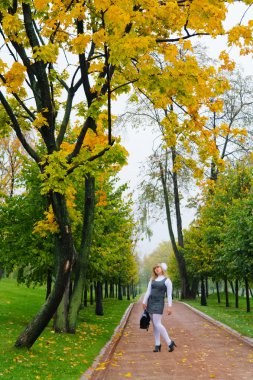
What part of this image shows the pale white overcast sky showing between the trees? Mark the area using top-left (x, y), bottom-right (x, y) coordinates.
top-left (113, 4), bottom-right (253, 255)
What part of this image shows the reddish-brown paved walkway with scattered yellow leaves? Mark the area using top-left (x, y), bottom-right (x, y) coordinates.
top-left (80, 302), bottom-right (253, 380)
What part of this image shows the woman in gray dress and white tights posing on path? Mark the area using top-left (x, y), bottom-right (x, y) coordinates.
top-left (143, 263), bottom-right (176, 352)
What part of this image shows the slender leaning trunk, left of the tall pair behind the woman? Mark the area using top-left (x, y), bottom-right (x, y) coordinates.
top-left (159, 159), bottom-right (191, 299)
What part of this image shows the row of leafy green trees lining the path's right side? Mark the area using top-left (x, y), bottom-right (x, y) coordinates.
top-left (185, 157), bottom-right (253, 311)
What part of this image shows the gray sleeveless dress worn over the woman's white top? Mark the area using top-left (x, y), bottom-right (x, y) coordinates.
top-left (147, 278), bottom-right (167, 314)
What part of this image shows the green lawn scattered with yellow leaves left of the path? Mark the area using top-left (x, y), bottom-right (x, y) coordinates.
top-left (0, 279), bottom-right (134, 380)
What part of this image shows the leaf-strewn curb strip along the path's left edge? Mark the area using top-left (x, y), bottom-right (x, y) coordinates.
top-left (79, 302), bottom-right (134, 380)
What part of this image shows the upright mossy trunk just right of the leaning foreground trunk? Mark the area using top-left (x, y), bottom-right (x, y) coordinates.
top-left (68, 175), bottom-right (95, 333)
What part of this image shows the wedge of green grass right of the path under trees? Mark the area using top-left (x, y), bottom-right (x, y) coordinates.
top-left (185, 293), bottom-right (253, 338)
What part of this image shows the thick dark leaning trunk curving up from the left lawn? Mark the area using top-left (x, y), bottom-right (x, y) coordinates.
top-left (15, 193), bottom-right (74, 348)
